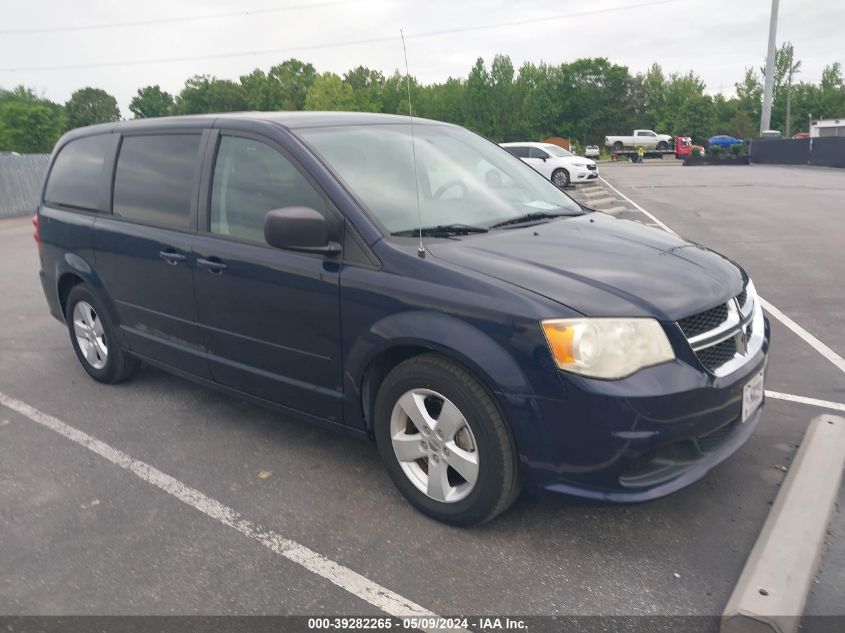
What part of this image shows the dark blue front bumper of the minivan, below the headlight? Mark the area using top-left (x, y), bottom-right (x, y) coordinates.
top-left (504, 321), bottom-right (769, 502)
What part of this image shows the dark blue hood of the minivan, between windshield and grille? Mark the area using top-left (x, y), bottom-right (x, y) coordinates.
top-left (427, 213), bottom-right (746, 321)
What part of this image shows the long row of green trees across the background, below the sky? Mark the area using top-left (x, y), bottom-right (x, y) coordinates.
top-left (0, 42), bottom-right (845, 153)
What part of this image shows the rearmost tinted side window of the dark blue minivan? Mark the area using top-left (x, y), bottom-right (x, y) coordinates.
top-left (44, 134), bottom-right (118, 211)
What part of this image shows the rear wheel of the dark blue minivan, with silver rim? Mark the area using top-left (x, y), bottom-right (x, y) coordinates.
top-left (65, 284), bottom-right (139, 384)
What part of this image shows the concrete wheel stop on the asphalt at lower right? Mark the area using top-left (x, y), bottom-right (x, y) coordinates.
top-left (721, 415), bottom-right (845, 633)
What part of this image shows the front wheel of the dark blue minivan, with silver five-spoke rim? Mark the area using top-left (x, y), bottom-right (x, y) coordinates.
top-left (374, 354), bottom-right (521, 526)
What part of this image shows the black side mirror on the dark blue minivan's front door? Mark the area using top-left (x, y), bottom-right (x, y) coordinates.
top-left (264, 207), bottom-right (341, 256)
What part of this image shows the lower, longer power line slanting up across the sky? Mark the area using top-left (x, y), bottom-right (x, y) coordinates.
top-left (0, 0), bottom-right (688, 72)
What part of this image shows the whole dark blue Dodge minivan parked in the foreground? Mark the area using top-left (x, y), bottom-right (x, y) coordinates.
top-left (35, 112), bottom-right (769, 525)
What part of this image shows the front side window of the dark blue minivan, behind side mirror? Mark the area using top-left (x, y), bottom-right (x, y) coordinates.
top-left (210, 136), bottom-right (328, 243)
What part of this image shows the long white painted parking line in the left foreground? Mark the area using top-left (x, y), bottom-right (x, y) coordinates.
top-left (0, 392), bottom-right (460, 631)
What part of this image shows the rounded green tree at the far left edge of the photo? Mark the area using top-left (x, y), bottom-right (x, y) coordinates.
top-left (0, 99), bottom-right (63, 154)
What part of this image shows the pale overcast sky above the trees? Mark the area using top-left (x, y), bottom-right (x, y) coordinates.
top-left (0, 0), bottom-right (845, 116)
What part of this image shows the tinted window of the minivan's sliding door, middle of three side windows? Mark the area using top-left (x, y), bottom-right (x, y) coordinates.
top-left (114, 134), bottom-right (200, 229)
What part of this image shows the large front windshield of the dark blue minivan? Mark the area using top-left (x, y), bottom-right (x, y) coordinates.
top-left (297, 123), bottom-right (583, 234)
